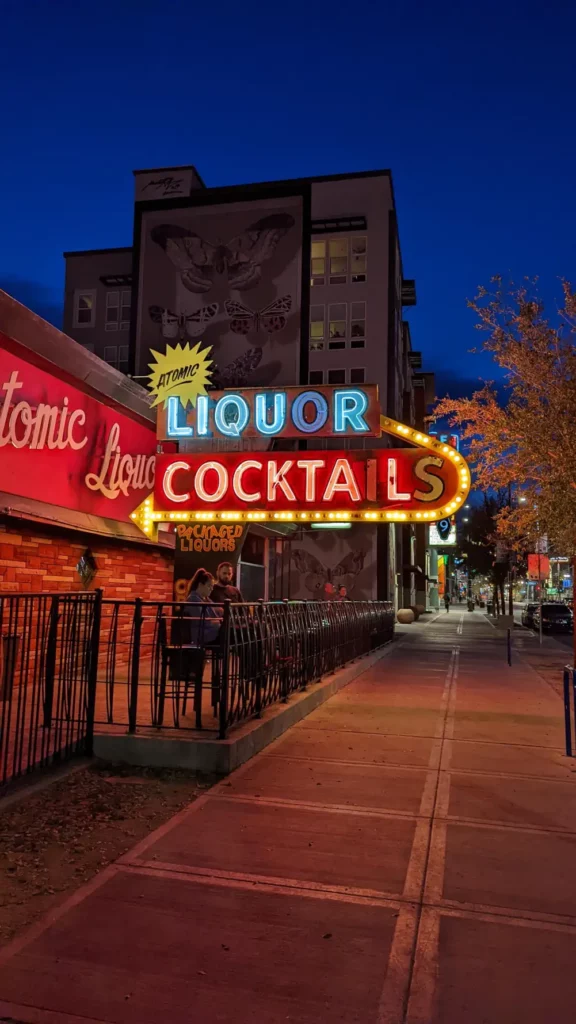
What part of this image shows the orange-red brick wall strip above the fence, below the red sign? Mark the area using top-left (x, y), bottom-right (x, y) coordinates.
top-left (0, 519), bottom-right (173, 601)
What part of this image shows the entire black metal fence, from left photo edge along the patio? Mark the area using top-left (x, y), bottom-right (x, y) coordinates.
top-left (0, 591), bottom-right (394, 787)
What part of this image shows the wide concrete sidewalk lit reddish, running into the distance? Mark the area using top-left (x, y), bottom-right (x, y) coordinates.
top-left (0, 608), bottom-right (576, 1024)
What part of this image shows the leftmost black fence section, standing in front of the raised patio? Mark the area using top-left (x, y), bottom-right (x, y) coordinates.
top-left (0, 592), bottom-right (101, 786)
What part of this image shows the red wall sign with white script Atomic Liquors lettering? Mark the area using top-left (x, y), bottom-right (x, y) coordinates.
top-left (0, 334), bottom-right (156, 520)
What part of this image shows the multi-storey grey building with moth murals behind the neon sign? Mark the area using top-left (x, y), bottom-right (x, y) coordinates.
top-left (65, 167), bottom-right (433, 604)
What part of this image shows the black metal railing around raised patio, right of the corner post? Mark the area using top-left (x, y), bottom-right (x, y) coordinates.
top-left (95, 599), bottom-right (394, 738)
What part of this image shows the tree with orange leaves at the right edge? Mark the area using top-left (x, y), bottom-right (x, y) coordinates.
top-left (436, 276), bottom-right (576, 555)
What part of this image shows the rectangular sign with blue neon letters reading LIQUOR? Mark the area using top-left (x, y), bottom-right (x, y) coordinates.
top-left (157, 384), bottom-right (382, 440)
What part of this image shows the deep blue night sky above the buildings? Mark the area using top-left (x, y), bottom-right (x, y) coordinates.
top-left (0, 0), bottom-right (576, 394)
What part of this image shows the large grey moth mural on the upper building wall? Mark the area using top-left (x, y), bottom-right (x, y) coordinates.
top-left (137, 197), bottom-right (301, 387)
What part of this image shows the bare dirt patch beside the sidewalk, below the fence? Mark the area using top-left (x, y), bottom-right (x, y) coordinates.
top-left (0, 763), bottom-right (215, 946)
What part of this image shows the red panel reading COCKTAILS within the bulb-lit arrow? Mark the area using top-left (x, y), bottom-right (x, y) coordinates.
top-left (154, 449), bottom-right (460, 519)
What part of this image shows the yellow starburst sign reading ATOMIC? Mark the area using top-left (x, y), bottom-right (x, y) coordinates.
top-left (149, 342), bottom-right (212, 409)
